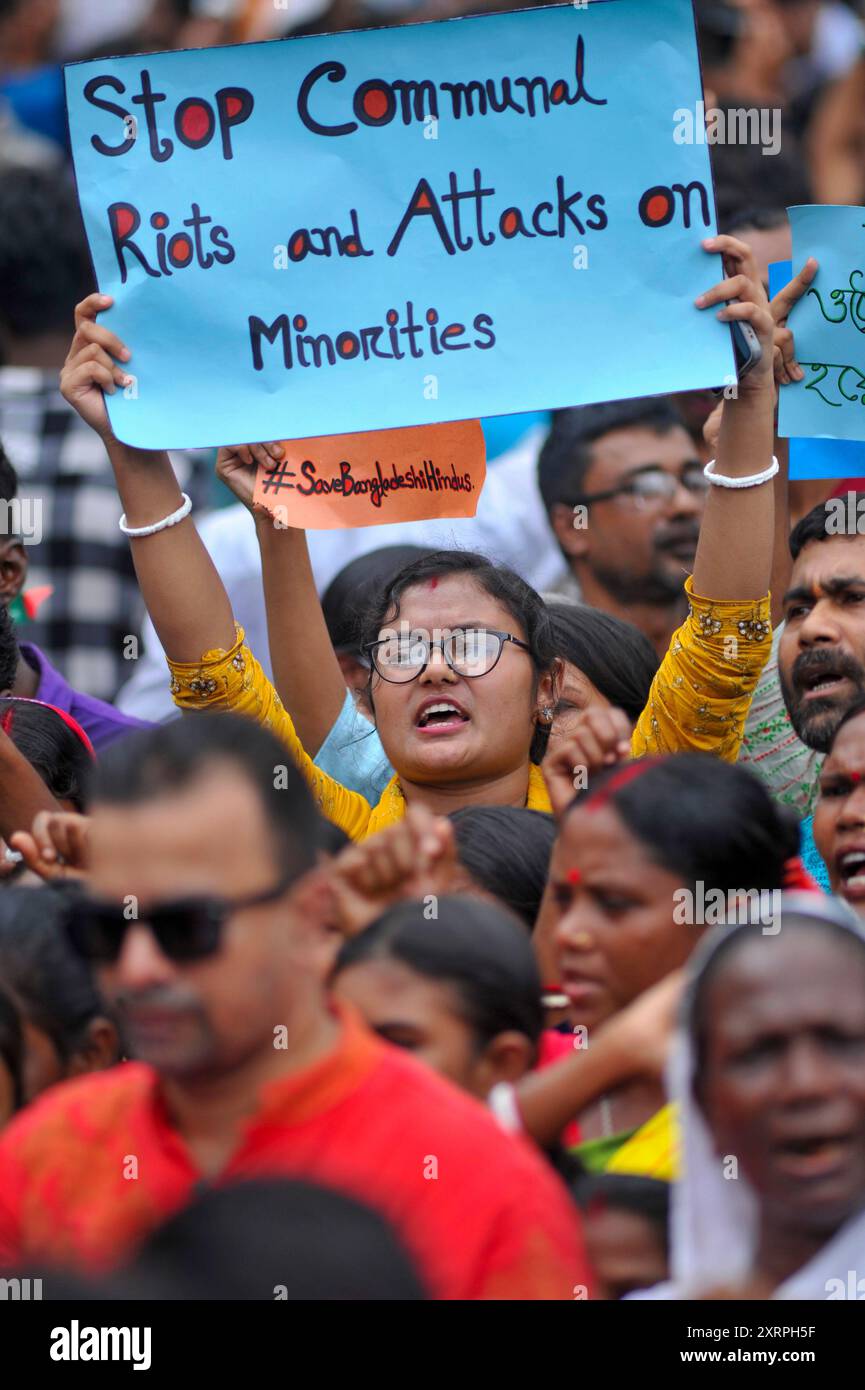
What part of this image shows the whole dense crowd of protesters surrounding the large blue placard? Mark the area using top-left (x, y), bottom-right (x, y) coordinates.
top-left (0, 0), bottom-right (865, 1301)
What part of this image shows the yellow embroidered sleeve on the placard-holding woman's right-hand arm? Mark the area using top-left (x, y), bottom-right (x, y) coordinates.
top-left (631, 577), bottom-right (772, 763)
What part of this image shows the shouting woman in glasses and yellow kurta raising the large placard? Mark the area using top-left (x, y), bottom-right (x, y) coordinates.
top-left (61, 236), bottom-right (777, 838)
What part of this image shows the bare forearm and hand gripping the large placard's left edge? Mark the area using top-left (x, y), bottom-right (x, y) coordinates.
top-left (60, 295), bottom-right (235, 662)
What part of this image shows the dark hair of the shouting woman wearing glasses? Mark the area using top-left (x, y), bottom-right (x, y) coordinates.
top-left (364, 550), bottom-right (558, 763)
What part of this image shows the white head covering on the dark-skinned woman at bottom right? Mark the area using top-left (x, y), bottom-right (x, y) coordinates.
top-left (633, 892), bottom-right (865, 1300)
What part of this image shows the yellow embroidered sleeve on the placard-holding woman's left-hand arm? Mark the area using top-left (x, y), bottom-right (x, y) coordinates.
top-left (168, 627), bottom-right (371, 840)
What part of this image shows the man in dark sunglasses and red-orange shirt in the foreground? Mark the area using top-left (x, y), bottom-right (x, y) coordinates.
top-left (0, 714), bottom-right (588, 1298)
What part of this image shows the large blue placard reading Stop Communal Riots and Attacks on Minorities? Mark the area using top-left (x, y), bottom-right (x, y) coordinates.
top-left (65, 0), bottom-right (734, 448)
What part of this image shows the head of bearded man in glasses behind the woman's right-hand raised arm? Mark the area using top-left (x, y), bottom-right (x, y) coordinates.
top-left (538, 399), bottom-right (708, 656)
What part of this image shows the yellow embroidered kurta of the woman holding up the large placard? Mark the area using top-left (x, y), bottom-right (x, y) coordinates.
top-left (168, 580), bottom-right (772, 840)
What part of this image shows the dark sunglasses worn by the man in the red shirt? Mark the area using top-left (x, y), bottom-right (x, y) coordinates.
top-left (64, 874), bottom-right (292, 965)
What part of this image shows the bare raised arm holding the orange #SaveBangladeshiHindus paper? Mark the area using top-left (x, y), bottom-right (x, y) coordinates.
top-left (217, 443), bottom-right (345, 756)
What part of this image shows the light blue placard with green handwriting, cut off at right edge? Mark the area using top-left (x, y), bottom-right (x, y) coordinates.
top-left (779, 206), bottom-right (865, 439)
